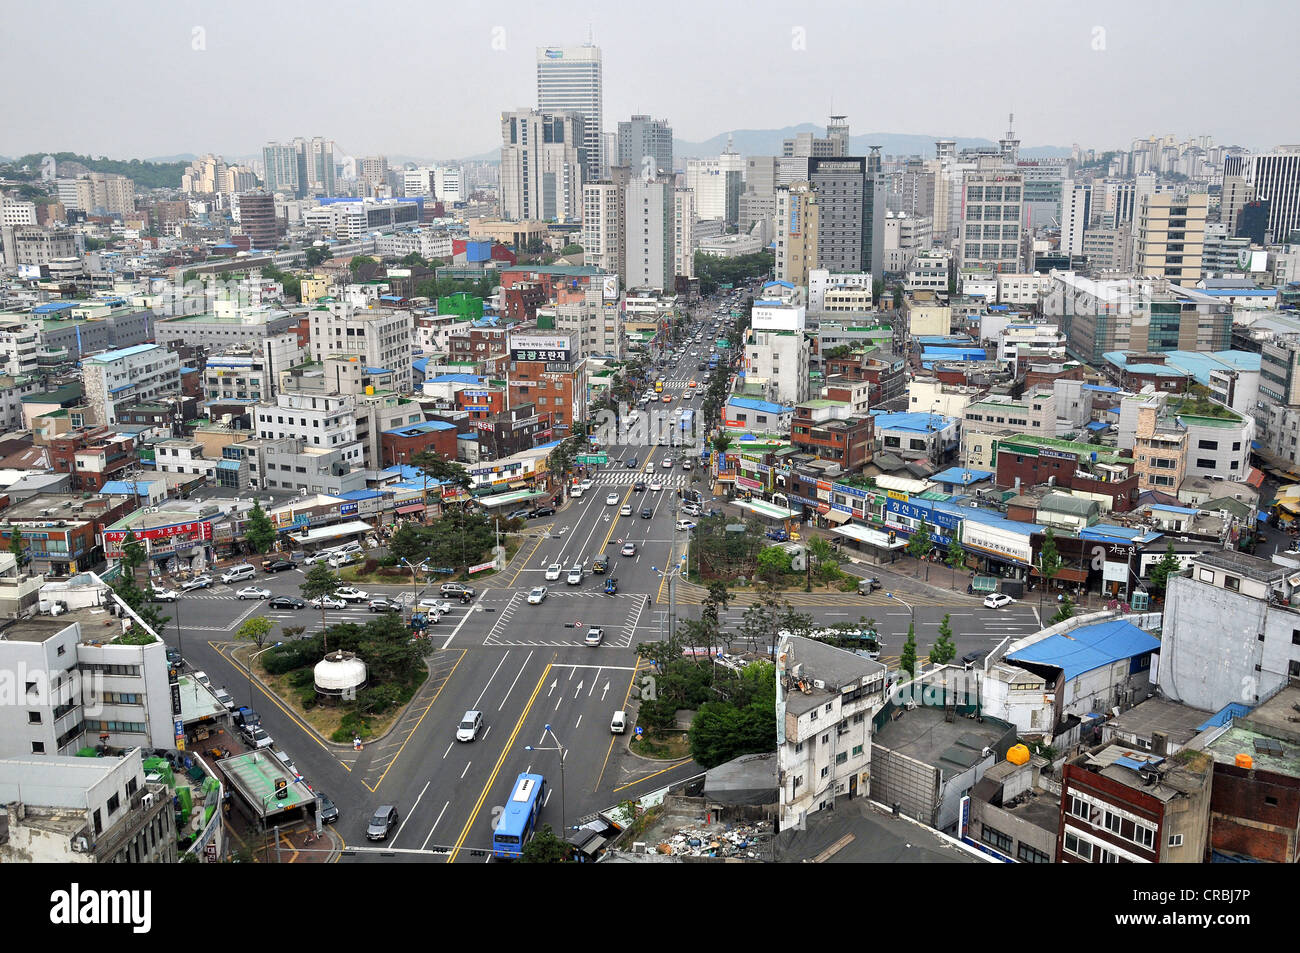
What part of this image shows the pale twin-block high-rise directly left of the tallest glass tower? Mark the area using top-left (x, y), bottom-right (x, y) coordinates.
top-left (501, 109), bottom-right (589, 221)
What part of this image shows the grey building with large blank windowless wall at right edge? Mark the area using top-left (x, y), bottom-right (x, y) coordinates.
top-left (1158, 551), bottom-right (1300, 711)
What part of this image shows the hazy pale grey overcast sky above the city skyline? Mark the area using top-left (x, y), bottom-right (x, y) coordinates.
top-left (0, 0), bottom-right (1300, 159)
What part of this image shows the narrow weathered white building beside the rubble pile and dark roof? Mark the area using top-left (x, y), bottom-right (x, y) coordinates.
top-left (776, 636), bottom-right (888, 827)
